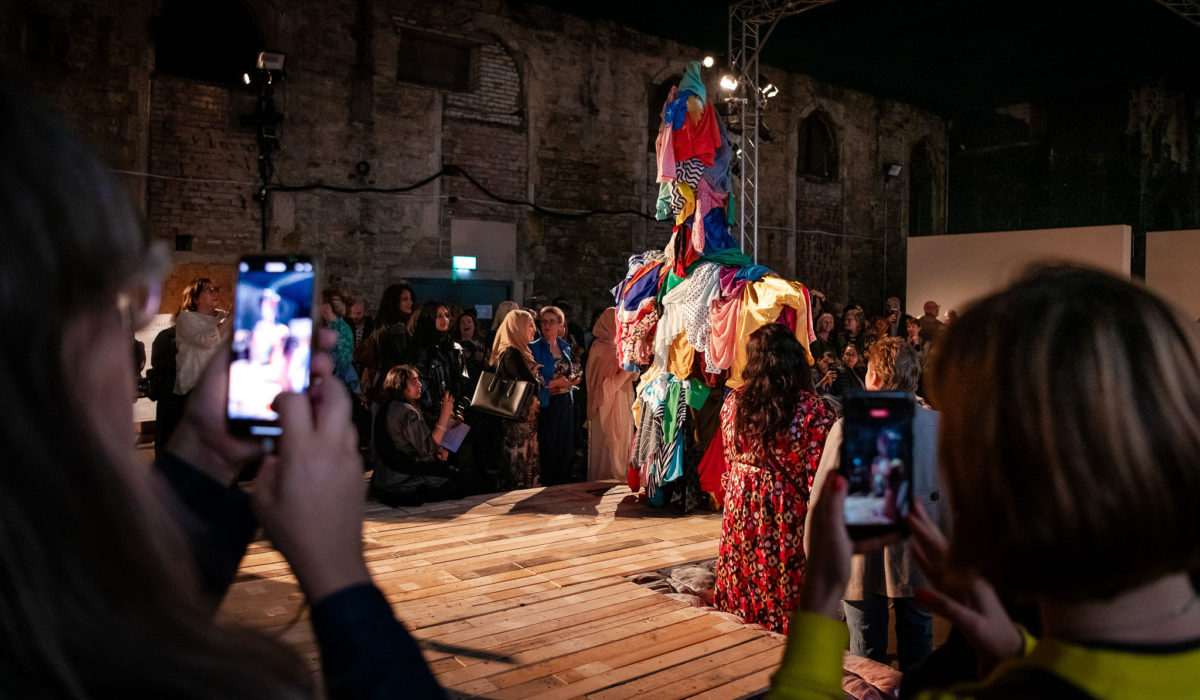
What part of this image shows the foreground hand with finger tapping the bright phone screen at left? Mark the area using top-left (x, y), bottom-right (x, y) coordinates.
top-left (253, 358), bottom-right (371, 603)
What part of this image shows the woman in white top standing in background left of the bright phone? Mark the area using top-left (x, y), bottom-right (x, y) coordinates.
top-left (175, 277), bottom-right (233, 394)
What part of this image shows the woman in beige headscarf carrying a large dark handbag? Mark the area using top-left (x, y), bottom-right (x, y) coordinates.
top-left (491, 309), bottom-right (541, 490)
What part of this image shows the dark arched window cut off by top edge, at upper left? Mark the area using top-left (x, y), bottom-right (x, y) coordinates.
top-left (155, 0), bottom-right (262, 85)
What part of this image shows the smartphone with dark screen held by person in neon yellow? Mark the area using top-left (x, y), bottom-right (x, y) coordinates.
top-left (838, 391), bottom-right (916, 539)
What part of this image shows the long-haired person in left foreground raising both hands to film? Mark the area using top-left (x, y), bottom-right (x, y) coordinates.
top-left (0, 84), bottom-right (439, 698)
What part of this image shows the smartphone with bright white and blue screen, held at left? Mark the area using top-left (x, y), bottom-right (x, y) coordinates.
top-left (226, 255), bottom-right (317, 437)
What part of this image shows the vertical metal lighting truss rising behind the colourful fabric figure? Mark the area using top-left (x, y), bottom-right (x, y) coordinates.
top-left (725, 0), bottom-right (840, 263)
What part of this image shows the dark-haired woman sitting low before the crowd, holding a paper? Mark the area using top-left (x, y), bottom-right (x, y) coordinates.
top-left (371, 365), bottom-right (454, 507)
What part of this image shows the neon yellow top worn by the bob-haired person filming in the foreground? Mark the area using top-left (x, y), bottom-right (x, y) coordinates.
top-left (768, 611), bottom-right (1200, 700)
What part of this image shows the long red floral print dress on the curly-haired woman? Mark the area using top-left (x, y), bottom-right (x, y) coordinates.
top-left (714, 389), bottom-right (836, 634)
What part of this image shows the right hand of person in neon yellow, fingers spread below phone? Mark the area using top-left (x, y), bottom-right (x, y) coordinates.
top-left (906, 502), bottom-right (1025, 671)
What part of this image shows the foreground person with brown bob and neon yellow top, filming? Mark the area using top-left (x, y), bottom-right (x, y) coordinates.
top-left (770, 265), bottom-right (1200, 700)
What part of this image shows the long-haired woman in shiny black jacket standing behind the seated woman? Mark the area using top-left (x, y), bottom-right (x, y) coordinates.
top-left (404, 301), bottom-right (473, 429)
